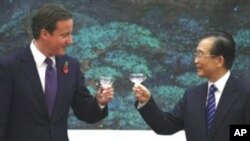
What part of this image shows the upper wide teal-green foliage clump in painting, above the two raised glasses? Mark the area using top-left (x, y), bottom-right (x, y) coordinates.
top-left (69, 22), bottom-right (160, 59)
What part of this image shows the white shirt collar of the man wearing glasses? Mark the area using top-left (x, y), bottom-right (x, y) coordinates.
top-left (208, 71), bottom-right (231, 93)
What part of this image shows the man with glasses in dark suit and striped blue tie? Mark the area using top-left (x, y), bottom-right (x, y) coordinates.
top-left (133, 31), bottom-right (250, 141)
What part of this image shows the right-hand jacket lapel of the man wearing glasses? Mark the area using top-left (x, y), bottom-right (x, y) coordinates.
top-left (210, 75), bottom-right (238, 137)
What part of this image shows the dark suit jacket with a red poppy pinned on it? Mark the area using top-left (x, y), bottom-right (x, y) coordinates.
top-left (0, 47), bottom-right (107, 141)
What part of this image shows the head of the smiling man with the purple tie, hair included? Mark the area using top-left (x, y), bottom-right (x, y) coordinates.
top-left (32, 4), bottom-right (73, 57)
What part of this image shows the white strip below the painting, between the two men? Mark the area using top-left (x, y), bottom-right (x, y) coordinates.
top-left (68, 130), bottom-right (186, 141)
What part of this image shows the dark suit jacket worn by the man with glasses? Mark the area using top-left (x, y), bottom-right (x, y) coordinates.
top-left (139, 75), bottom-right (250, 141)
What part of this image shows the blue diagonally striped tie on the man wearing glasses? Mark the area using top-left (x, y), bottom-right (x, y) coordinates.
top-left (206, 84), bottom-right (217, 134)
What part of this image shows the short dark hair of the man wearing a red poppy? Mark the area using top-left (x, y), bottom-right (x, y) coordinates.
top-left (32, 4), bottom-right (72, 39)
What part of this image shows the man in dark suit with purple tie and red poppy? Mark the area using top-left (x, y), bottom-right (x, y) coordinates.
top-left (0, 5), bottom-right (113, 141)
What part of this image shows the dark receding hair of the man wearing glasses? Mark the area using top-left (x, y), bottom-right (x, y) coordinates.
top-left (202, 31), bottom-right (235, 69)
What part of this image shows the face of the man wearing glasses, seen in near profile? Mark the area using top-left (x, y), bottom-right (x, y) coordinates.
top-left (194, 38), bottom-right (218, 80)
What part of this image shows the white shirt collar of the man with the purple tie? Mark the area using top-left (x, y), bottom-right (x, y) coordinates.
top-left (30, 40), bottom-right (56, 67)
